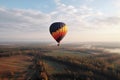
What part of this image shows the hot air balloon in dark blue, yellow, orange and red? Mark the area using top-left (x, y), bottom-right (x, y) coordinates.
top-left (49, 22), bottom-right (67, 46)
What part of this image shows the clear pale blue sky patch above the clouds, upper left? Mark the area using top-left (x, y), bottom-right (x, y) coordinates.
top-left (0, 0), bottom-right (56, 12)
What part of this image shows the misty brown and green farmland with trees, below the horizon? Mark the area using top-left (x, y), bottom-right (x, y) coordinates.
top-left (0, 42), bottom-right (120, 80)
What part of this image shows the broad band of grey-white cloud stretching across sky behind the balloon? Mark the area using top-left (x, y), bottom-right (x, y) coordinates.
top-left (0, 0), bottom-right (119, 32)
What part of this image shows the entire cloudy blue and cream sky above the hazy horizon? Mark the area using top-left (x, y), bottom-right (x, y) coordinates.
top-left (0, 0), bottom-right (120, 43)
